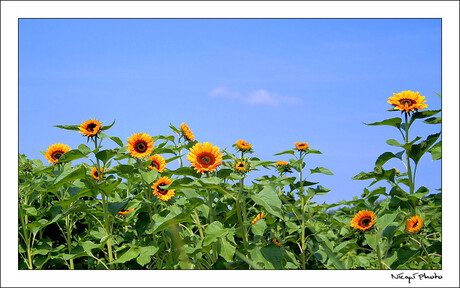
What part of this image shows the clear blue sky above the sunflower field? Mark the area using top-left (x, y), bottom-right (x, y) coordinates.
top-left (19, 19), bottom-right (442, 203)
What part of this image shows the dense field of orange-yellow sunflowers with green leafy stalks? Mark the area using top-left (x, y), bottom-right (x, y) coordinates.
top-left (18, 91), bottom-right (442, 270)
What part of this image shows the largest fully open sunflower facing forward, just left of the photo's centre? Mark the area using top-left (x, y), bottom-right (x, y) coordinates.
top-left (187, 142), bottom-right (223, 173)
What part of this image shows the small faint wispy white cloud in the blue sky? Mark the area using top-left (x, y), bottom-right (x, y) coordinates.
top-left (209, 87), bottom-right (302, 106)
